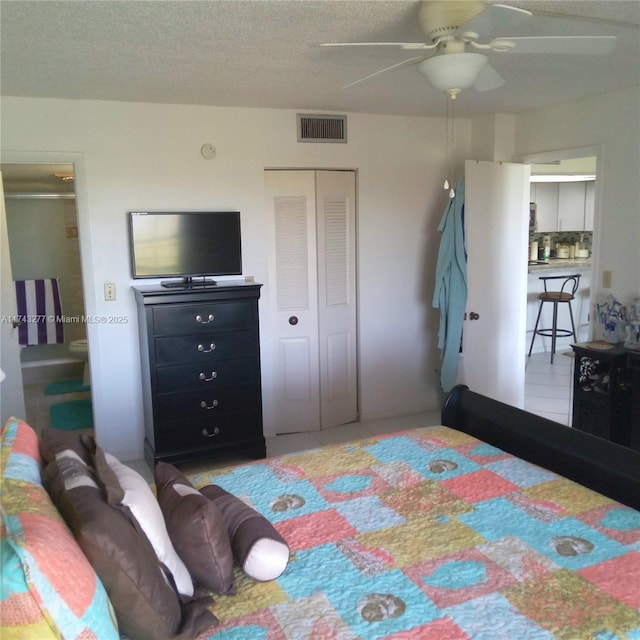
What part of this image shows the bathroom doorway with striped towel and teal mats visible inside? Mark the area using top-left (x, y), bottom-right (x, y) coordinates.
top-left (1, 162), bottom-right (93, 438)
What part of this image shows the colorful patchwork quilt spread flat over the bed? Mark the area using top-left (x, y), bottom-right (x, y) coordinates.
top-left (189, 427), bottom-right (640, 640)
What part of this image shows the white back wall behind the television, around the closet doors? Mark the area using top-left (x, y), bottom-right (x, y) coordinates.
top-left (2, 98), bottom-right (460, 460)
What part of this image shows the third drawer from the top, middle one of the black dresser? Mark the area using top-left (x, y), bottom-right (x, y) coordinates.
top-left (156, 356), bottom-right (260, 394)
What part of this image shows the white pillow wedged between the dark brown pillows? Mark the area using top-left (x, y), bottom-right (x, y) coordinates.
top-left (105, 452), bottom-right (193, 597)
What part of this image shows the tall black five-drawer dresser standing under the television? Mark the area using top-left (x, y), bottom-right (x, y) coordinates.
top-left (134, 281), bottom-right (266, 464)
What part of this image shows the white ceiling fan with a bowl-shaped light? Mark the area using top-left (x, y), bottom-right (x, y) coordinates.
top-left (320, 0), bottom-right (616, 99)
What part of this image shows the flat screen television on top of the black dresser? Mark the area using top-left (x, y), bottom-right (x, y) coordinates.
top-left (129, 211), bottom-right (242, 287)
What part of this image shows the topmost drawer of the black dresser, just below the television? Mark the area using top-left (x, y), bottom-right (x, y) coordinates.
top-left (153, 301), bottom-right (254, 336)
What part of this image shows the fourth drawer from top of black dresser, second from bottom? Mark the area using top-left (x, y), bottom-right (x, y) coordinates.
top-left (155, 384), bottom-right (260, 422)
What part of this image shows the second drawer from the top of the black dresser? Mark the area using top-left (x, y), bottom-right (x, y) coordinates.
top-left (154, 330), bottom-right (257, 365)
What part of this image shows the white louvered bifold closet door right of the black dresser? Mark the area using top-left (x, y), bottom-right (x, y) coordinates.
top-left (265, 171), bottom-right (357, 433)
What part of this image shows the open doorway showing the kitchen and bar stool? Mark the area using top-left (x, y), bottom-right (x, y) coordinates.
top-left (524, 147), bottom-right (601, 425)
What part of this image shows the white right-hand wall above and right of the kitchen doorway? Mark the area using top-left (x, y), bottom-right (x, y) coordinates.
top-left (515, 87), bottom-right (640, 302)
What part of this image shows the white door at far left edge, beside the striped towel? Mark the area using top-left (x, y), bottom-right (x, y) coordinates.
top-left (0, 173), bottom-right (26, 424)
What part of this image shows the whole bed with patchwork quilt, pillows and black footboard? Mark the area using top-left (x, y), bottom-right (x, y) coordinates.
top-left (0, 386), bottom-right (640, 640)
